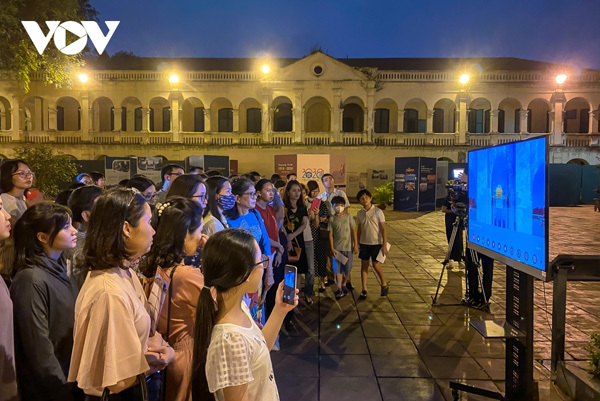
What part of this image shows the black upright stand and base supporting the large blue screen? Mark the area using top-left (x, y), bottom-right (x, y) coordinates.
top-left (450, 266), bottom-right (539, 401)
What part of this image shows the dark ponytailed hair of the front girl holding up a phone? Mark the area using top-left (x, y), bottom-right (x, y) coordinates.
top-left (192, 229), bottom-right (256, 401)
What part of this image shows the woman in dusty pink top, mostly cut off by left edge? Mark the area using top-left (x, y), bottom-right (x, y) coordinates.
top-left (0, 198), bottom-right (18, 401)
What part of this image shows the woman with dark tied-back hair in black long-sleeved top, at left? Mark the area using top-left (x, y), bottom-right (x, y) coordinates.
top-left (10, 202), bottom-right (77, 401)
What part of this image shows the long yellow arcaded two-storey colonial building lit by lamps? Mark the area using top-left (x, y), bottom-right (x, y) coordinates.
top-left (0, 52), bottom-right (600, 173)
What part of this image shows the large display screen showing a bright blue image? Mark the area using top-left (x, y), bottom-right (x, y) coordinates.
top-left (468, 136), bottom-right (548, 280)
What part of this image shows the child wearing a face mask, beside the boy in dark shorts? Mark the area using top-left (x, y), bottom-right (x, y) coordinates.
top-left (328, 196), bottom-right (358, 299)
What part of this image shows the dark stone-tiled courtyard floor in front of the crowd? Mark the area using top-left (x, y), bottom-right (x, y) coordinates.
top-left (271, 205), bottom-right (600, 401)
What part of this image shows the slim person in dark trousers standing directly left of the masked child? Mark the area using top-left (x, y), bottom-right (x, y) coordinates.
top-left (306, 180), bottom-right (329, 292)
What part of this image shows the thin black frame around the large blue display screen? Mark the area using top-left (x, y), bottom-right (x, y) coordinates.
top-left (466, 135), bottom-right (552, 281)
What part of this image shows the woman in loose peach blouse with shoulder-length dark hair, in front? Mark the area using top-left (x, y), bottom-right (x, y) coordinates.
top-left (69, 187), bottom-right (174, 401)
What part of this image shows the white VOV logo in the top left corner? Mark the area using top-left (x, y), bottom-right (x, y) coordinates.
top-left (21, 21), bottom-right (120, 56)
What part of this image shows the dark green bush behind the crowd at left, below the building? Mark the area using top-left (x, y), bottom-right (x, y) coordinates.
top-left (15, 145), bottom-right (77, 198)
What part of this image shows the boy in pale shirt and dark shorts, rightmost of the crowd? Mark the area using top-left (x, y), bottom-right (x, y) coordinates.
top-left (356, 189), bottom-right (389, 299)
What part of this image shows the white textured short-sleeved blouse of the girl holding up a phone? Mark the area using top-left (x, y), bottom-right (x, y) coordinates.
top-left (206, 302), bottom-right (279, 401)
